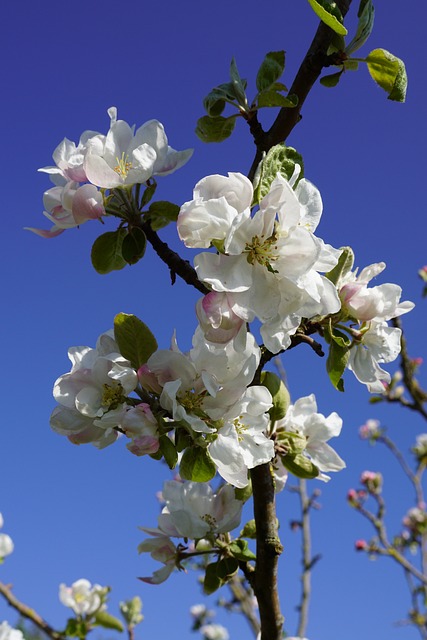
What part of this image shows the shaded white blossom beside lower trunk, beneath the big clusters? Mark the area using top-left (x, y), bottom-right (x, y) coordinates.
top-left (158, 480), bottom-right (243, 540)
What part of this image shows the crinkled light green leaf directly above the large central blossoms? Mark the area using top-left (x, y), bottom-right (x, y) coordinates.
top-left (254, 144), bottom-right (304, 204)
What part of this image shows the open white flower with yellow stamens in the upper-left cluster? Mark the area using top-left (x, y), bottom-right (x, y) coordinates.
top-left (83, 107), bottom-right (193, 189)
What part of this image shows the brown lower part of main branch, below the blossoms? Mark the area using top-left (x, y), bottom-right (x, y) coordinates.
top-left (251, 463), bottom-right (284, 640)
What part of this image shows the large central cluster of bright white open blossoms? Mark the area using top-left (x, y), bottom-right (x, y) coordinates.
top-left (177, 165), bottom-right (341, 353)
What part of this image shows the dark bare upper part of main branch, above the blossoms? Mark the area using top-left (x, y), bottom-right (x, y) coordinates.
top-left (248, 0), bottom-right (351, 180)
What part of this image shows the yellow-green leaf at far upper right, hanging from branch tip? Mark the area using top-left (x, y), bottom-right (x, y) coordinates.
top-left (365, 49), bottom-right (408, 102)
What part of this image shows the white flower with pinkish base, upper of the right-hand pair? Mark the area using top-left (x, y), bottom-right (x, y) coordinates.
top-left (338, 262), bottom-right (415, 323)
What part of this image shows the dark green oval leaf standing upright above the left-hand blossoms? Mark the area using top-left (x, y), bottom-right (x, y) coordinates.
top-left (114, 313), bottom-right (157, 370)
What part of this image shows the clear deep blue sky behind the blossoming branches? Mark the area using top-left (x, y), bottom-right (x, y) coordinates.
top-left (0, 0), bottom-right (427, 640)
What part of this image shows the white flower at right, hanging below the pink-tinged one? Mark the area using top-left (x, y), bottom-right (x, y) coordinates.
top-left (347, 322), bottom-right (402, 393)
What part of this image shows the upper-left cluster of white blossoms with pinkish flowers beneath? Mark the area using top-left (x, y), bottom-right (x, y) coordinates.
top-left (28, 107), bottom-right (193, 238)
